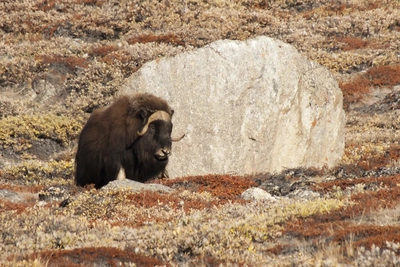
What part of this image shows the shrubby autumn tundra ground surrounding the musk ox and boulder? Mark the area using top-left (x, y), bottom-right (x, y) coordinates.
top-left (0, 0), bottom-right (400, 266)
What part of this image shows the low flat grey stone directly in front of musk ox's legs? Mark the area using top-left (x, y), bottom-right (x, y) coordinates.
top-left (101, 179), bottom-right (173, 193)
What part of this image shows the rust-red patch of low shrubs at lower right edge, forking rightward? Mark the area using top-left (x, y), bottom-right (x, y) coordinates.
top-left (285, 184), bottom-right (400, 253)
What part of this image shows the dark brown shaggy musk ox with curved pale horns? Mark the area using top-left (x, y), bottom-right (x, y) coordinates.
top-left (75, 93), bottom-right (183, 188)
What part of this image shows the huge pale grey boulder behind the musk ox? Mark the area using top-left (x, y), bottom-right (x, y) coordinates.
top-left (120, 37), bottom-right (345, 177)
